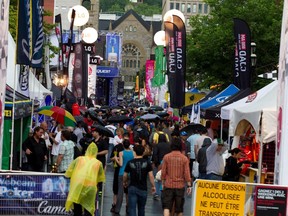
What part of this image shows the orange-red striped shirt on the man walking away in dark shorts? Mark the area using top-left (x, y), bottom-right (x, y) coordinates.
top-left (161, 151), bottom-right (191, 189)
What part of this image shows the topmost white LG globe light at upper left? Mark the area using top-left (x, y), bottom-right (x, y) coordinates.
top-left (68, 5), bottom-right (89, 26)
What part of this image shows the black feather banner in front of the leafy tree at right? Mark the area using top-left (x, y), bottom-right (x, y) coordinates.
top-left (234, 18), bottom-right (251, 89)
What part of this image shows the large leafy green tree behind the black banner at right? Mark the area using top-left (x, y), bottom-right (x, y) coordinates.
top-left (187, 0), bottom-right (283, 88)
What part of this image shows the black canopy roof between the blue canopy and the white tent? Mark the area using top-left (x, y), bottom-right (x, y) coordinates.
top-left (201, 88), bottom-right (252, 119)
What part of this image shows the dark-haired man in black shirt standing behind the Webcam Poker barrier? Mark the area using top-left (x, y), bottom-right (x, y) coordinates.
top-left (22, 126), bottom-right (48, 172)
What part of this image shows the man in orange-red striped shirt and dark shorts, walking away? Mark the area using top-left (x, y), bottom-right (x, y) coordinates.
top-left (161, 138), bottom-right (192, 216)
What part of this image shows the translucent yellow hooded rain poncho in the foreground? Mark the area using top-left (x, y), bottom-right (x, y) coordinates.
top-left (65, 142), bottom-right (105, 215)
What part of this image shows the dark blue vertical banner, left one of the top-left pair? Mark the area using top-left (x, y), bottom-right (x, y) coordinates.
top-left (16, 0), bottom-right (30, 65)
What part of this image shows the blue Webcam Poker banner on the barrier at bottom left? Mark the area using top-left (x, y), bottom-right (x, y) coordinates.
top-left (0, 173), bottom-right (72, 215)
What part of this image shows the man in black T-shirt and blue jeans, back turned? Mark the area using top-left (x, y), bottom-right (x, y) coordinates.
top-left (123, 145), bottom-right (156, 216)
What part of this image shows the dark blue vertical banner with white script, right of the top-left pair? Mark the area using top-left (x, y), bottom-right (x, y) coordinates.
top-left (31, 0), bottom-right (44, 68)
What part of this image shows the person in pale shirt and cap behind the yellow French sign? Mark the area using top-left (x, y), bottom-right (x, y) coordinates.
top-left (206, 139), bottom-right (228, 181)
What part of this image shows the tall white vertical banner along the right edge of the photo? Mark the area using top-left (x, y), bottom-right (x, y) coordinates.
top-left (274, 0), bottom-right (288, 185)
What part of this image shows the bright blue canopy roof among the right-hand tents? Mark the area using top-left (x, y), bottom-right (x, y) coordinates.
top-left (200, 84), bottom-right (239, 109)
